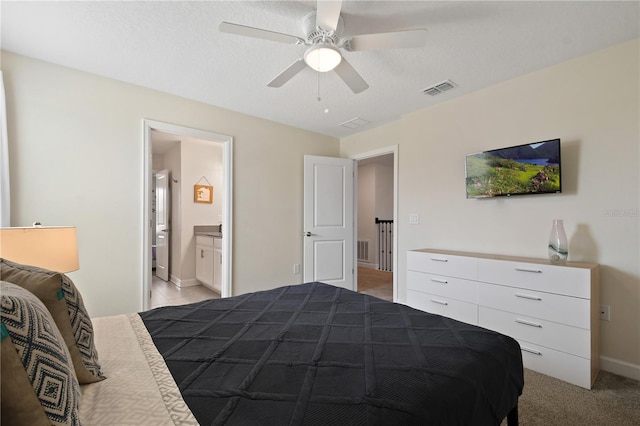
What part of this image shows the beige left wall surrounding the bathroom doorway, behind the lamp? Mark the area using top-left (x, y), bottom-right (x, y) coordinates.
top-left (2, 52), bottom-right (339, 316)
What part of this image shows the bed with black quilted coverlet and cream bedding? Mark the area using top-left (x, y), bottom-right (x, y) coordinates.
top-left (3, 260), bottom-right (524, 425)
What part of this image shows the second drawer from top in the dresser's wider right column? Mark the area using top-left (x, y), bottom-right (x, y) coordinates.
top-left (478, 283), bottom-right (591, 329)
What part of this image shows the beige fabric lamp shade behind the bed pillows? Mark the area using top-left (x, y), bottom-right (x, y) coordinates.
top-left (0, 226), bottom-right (80, 272)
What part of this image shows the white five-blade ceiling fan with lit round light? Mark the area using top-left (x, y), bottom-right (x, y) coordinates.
top-left (219, 0), bottom-right (427, 93)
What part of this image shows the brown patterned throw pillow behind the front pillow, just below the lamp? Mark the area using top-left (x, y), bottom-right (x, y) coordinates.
top-left (0, 259), bottom-right (105, 384)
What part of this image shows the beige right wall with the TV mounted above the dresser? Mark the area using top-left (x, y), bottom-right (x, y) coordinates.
top-left (341, 40), bottom-right (640, 373)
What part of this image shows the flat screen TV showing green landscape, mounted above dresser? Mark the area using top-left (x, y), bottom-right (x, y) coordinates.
top-left (465, 139), bottom-right (562, 198)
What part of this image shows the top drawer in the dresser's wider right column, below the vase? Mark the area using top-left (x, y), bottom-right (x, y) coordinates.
top-left (478, 259), bottom-right (591, 299)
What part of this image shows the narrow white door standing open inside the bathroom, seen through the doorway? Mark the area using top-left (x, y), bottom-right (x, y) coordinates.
top-left (155, 170), bottom-right (171, 281)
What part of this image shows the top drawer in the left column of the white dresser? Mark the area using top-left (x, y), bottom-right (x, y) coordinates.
top-left (407, 251), bottom-right (478, 280)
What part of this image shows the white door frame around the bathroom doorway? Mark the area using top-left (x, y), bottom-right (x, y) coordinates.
top-left (141, 119), bottom-right (233, 310)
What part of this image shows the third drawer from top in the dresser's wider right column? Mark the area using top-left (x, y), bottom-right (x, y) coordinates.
top-left (478, 306), bottom-right (591, 359)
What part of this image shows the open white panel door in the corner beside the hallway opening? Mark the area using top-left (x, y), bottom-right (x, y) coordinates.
top-left (304, 155), bottom-right (355, 290)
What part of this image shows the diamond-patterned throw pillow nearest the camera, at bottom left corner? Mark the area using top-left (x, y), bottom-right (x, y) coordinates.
top-left (0, 281), bottom-right (80, 425)
